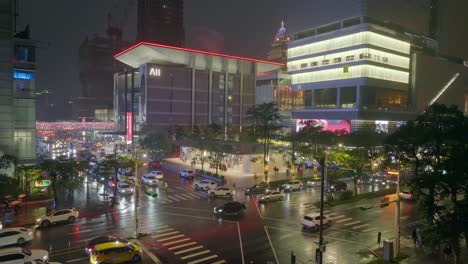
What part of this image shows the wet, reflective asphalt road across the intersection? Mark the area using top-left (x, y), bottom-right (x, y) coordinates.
top-left (20, 166), bottom-right (420, 264)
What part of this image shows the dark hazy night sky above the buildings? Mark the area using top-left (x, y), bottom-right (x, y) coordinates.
top-left (17, 0), bottom-right (468, 119)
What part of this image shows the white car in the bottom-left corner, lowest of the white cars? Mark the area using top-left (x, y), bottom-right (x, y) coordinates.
top-left (0, 247), bottom-right (49, 263)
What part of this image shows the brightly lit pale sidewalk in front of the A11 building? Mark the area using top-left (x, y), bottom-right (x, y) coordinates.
top-left (165, 158), bottom-right (291, 188)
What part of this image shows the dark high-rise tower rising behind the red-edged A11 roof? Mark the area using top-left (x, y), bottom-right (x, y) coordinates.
top-left (136, 0), bottom-right (185, 47)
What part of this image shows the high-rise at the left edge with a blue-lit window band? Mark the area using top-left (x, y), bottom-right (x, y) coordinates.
top-left (0, 0), bottom-right (37, 164)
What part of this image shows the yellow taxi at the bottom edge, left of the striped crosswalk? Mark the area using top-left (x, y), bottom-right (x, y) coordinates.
top-left (89, 241), bottom-right (142, 264)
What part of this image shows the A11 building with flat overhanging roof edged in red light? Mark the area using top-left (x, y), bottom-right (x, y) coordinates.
top-left (114, 42), bottom-right (284, 133)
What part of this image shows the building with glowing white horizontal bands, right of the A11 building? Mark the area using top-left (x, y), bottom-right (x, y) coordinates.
top-left (287, 17), bottom-right (465, 132)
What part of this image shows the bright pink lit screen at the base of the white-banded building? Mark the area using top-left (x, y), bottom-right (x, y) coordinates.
top-left (296, 119), bottom-right (351, 134)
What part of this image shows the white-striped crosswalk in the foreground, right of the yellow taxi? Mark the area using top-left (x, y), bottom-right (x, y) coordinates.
top-left (151, 226), bottom-right (226, 264)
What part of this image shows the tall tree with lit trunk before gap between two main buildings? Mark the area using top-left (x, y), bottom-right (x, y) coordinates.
top-left (247, 102), bottom-right (281, 183)
